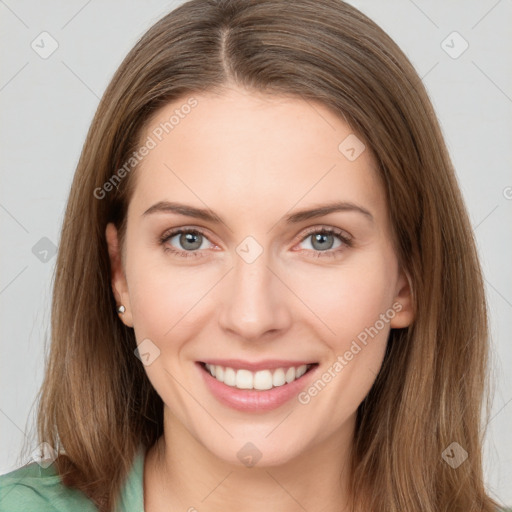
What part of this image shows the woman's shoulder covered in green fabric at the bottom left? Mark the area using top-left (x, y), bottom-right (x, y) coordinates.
top-left (0, 462), bottom-right (97, 512)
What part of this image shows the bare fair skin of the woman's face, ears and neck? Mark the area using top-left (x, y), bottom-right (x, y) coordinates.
top-left (106, 86), bottom-right (413, 512)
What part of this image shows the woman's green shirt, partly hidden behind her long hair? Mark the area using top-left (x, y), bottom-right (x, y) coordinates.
top-left (0, 445), bottom-right (145, 512)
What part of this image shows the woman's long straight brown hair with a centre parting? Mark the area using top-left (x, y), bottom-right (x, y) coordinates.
top-left (24, 0), bottom-right (498, 512)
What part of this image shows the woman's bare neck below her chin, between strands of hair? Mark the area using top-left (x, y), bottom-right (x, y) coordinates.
top-left (144, 406), bottom-right (354, 512)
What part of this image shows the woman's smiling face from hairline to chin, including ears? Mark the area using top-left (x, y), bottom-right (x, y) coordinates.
top-left (107, 89), bottom-right (412, 465)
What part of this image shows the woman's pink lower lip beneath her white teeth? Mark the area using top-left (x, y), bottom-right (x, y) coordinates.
top-left (196, 363), bottom-right (318, 412)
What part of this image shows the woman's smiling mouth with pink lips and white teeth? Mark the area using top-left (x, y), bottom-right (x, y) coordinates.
top-left (196, 361), bottom-right (319, 412)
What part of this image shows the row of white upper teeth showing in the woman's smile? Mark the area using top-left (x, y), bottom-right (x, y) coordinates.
top-left (205, 364), bottom-right (311, 391)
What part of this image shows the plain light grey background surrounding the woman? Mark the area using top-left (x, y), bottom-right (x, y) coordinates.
top-left (0, 0), bottom-right (512, 504)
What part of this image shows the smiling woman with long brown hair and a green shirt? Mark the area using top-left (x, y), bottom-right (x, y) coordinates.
top-left (0, 0), bottom-right (508, 512)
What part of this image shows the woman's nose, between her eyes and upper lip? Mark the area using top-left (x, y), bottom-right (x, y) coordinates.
top-left (219, 251), bottom-right (293, 341)
